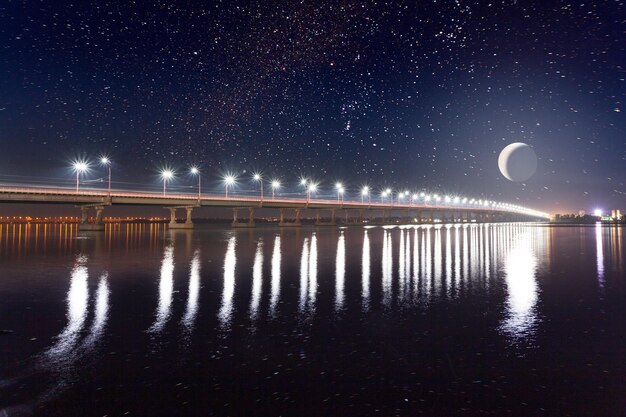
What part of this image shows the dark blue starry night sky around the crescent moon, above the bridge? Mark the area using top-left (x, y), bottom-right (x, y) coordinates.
top-left (0, 0), bottom-right (626, 212)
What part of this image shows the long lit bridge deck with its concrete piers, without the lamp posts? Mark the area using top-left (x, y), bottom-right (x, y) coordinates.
top-left (0, 186), bottom-right (549, 230)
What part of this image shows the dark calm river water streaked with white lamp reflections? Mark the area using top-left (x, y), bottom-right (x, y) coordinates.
top-left (0, 224), bottom-right (626, 417)
